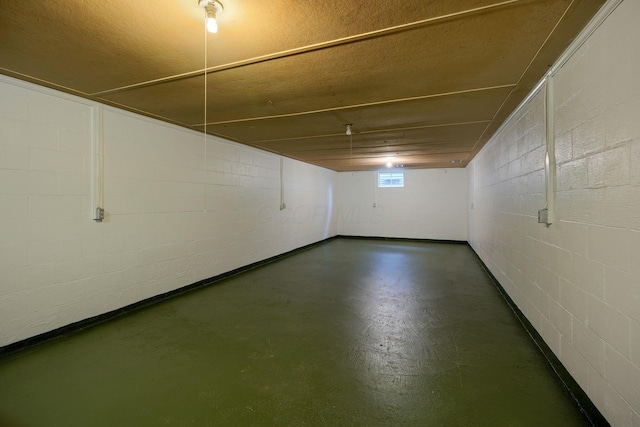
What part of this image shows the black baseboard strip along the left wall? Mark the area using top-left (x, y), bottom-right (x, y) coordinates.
top-left (0, 236), bottom-right (338, 358)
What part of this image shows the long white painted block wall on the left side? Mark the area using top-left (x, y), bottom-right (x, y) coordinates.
top-left (0, 77), bottom-right (337, 346)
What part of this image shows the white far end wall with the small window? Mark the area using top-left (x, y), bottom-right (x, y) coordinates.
top-left (336, 168), bottom-right (468, 241)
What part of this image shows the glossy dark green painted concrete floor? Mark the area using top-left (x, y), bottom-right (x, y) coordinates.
top-left (0, 239), bottom-right (586, 427)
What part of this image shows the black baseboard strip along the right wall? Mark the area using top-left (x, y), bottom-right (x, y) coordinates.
top-left (469, 245), bottom-right (610, 427)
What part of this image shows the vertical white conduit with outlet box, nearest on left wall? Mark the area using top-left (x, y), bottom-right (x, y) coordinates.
top-left (91, 105), bottom-right (104, 222)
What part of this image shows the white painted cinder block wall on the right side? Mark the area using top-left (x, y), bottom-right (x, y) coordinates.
top-left (468, 0), bottom-right (640, 426)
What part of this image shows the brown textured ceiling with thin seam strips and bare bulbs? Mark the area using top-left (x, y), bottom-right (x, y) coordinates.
top-left (0, 0), bottom-right (604, 171)
